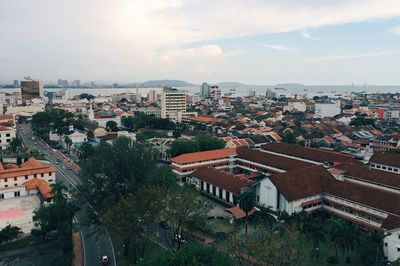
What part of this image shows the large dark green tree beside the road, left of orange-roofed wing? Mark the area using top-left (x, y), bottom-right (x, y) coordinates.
top-left (79, 137), bottom-right (161, 210)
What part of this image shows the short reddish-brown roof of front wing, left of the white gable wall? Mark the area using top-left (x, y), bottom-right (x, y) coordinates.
top-left (191, 167), bottom-right (252, 195)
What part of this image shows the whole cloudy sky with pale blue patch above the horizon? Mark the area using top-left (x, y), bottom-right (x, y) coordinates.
top-left (0, 0), bottom-right (400, 85)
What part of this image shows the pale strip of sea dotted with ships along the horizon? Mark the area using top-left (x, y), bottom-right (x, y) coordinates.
top-left (0, 84), bottom-right (400, 98)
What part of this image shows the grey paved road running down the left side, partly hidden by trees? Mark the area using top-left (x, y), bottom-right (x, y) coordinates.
top-left (17, 124), bottom-right (116, 266)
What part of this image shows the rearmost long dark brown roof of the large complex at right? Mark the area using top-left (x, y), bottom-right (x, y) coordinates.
top-left (262, 143), bottom-right (362, 165)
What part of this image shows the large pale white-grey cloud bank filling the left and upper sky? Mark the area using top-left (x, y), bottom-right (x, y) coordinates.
top-left (0, 0), bottom-right (400, 80)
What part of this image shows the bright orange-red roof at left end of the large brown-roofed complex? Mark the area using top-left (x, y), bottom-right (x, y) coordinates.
top-left (171, 148), bottom-right (236, 164)
